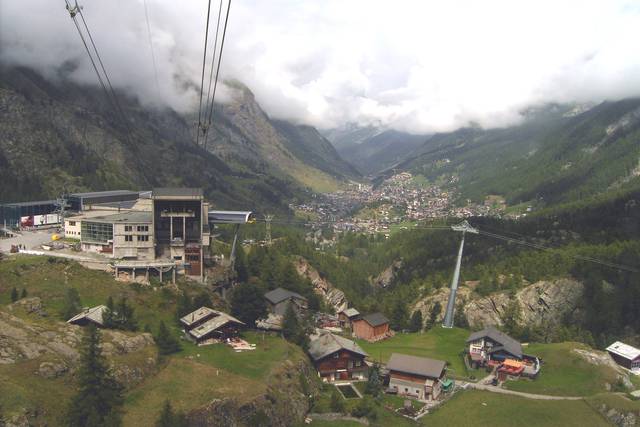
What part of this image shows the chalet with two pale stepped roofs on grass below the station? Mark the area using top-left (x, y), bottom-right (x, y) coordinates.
top-left (180, 307), bottom-right (245, 345)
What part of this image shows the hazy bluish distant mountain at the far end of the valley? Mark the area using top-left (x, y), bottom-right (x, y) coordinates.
top-left (337, 130), bottom-right (428, 175)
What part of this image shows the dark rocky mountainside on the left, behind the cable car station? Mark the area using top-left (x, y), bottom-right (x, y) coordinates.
top-left (0, 67), bottom-right (357, 211)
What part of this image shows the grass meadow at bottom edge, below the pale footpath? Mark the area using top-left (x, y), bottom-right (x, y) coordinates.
top-left (420, 390), bottom-right (610, 427)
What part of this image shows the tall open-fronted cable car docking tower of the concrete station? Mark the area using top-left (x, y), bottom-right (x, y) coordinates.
top-left (151, 188), bottom-right (211, 277)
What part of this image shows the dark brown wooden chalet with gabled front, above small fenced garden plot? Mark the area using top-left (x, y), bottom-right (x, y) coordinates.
top-left (309, 332), bottom-right (369, 382)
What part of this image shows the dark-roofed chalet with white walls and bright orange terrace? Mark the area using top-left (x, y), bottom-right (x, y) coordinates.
top-left (467, 326), bottom-right (540, 377)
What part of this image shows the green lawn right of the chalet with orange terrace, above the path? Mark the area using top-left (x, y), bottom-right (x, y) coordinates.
top-left (505, 342), bottom-right (617, 396)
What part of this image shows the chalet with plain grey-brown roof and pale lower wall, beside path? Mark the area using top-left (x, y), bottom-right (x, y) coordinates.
top-left (387, 353), bottom-right (449, 400)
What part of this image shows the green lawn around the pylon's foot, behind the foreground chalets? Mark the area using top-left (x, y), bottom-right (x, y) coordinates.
top-left (357, 326), bottom-right (478, 378)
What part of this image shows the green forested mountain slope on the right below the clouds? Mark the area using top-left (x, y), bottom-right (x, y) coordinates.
top-left (390, 99), bottom-right (640, 204)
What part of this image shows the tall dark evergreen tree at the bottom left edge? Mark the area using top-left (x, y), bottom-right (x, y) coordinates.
top-left (67, 325), bottom-right (123, 427)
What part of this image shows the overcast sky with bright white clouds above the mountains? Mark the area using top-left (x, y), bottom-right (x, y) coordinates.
top-left (0, 0), bottom-right (640, 133)
